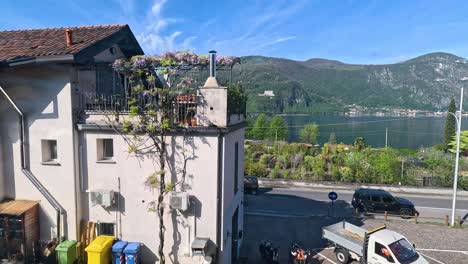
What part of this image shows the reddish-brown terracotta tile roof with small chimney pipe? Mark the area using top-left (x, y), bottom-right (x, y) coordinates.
top-left (0, 25), bottom-right (128, 62)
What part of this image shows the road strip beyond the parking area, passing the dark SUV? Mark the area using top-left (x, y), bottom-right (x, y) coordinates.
top-left (246, 188), bottom-right (468, 222)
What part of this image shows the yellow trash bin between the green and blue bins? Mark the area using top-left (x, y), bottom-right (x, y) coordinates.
top-left (85, 236), bottom-right (114, 264)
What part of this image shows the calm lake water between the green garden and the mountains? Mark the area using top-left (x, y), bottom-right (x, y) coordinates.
top-left (283, 115), bottom-right (468, 149)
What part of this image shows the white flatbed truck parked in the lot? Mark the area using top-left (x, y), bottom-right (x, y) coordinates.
top-left (322, 221), bottom-right (429, 264)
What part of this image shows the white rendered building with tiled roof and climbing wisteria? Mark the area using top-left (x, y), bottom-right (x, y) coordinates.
top-left (0, 25), bottom-right (244, 263)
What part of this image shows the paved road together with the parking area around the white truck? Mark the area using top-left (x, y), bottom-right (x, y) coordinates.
top-left (240, 188), bottom-right (468, 264)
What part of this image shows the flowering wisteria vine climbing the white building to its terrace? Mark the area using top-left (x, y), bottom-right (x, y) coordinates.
top-left (107, 51), bottom-right (238, 264)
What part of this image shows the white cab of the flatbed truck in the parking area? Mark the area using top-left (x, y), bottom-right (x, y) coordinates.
top-left (366, 229), bottom-right (428, 264)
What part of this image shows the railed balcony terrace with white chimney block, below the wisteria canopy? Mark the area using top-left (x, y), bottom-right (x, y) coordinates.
top-left (79, 87), bottom-right (246, 127)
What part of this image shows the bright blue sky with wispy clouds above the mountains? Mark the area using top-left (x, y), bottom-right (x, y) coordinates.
top-left (0, 0), bottom-right (468, 64)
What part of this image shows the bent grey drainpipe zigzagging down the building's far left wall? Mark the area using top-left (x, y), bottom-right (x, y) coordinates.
top-left (0, 86), bottom-right (65, 242)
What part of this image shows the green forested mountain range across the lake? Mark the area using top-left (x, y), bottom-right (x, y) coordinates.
top-left (234, 52), bottom-right (468, 112)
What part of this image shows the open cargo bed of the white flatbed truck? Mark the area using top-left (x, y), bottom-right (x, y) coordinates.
top-left (322, 221), bottom-right (366, 256)
